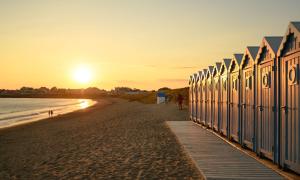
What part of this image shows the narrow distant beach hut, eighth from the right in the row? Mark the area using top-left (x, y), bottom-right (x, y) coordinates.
top-left (199, 69), bottom-right (207, 125)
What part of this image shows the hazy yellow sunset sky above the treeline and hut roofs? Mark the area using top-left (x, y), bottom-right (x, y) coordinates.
top-left (0, 0), bottom-right (300, 90)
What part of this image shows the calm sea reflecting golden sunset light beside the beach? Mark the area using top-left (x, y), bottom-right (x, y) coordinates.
top-left (0, 98), bottom-right (97, 128)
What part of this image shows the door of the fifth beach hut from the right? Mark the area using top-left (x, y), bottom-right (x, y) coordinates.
top-left (220, 77), bottom-right (227, 135)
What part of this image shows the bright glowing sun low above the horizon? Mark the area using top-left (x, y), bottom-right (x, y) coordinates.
top-left (73, 66), bottom-right (92, 84)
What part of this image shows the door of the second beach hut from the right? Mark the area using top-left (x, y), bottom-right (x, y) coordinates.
top-left (257, 61), bottom-right (275, 159)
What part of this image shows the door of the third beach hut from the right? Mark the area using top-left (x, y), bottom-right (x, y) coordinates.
top-left (242, 68), bottom-right (254, 149)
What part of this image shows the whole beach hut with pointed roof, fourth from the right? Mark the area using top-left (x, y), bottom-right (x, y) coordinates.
top-left (228, 54), bottom-right (243, 142)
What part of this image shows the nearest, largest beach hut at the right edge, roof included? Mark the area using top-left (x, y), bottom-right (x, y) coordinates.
top-left (277, 22), bottom-right (300, 173)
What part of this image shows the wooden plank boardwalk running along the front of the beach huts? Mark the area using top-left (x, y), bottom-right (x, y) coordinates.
top-left (166, 121), bottom-right (284, 180)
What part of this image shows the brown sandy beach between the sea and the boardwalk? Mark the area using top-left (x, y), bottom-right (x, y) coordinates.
top-left (0, 99), bottom-right (201, 179)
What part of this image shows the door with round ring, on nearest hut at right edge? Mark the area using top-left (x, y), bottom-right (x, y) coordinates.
top-left (281, 52), bottom-right (300, 173)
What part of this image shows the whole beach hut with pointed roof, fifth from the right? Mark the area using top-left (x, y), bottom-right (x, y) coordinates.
top-left (219, 59), bottom-right (231, 136)
